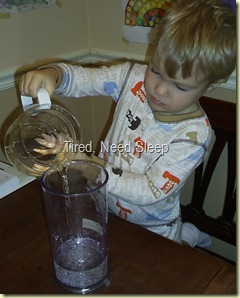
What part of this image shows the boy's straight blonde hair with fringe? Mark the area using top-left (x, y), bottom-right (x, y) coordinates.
top-left (155, 0), bottom-right (236, 82)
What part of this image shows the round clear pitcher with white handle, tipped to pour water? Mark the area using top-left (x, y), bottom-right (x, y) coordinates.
top-left (4, 88), bottom-right (82, 177)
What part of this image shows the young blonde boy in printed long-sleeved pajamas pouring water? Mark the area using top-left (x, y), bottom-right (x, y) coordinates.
top-left (20, 0), bottom-right (236, 246)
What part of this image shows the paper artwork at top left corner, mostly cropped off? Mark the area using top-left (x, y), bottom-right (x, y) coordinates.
top-left (0, 0), bottom-right (56, 13)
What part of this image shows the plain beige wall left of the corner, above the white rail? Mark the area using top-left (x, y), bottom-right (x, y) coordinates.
top-left (0, 0), bottom-right (89, 71)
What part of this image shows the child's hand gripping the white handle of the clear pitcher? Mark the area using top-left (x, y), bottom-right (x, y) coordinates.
top-left (19, 67), bottom-right (58, 98)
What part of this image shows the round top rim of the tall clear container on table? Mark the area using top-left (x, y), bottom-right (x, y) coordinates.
top-left (40, 160), bottom-right (109, 197)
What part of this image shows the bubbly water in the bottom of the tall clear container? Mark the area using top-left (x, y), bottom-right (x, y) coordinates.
top-left (54, 238), bottom-right (108, 288)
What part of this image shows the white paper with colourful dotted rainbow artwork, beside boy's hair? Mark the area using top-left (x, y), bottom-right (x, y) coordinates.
top-left (122, 0), bottom-right (176, 44)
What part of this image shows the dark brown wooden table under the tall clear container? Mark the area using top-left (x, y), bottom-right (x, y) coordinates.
top-left (0, 181), bottom-right (236, 294)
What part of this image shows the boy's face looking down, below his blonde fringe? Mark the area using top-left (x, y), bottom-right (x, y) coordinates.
top-left (145, 59), bottom-right (210, 115)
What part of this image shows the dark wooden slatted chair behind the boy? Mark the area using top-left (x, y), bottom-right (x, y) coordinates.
top-left (181, 97), bottom-right (236, 249)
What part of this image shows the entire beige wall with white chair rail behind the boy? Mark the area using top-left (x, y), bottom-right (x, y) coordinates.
top-left (0, 0), bottom-right (236, 259)
